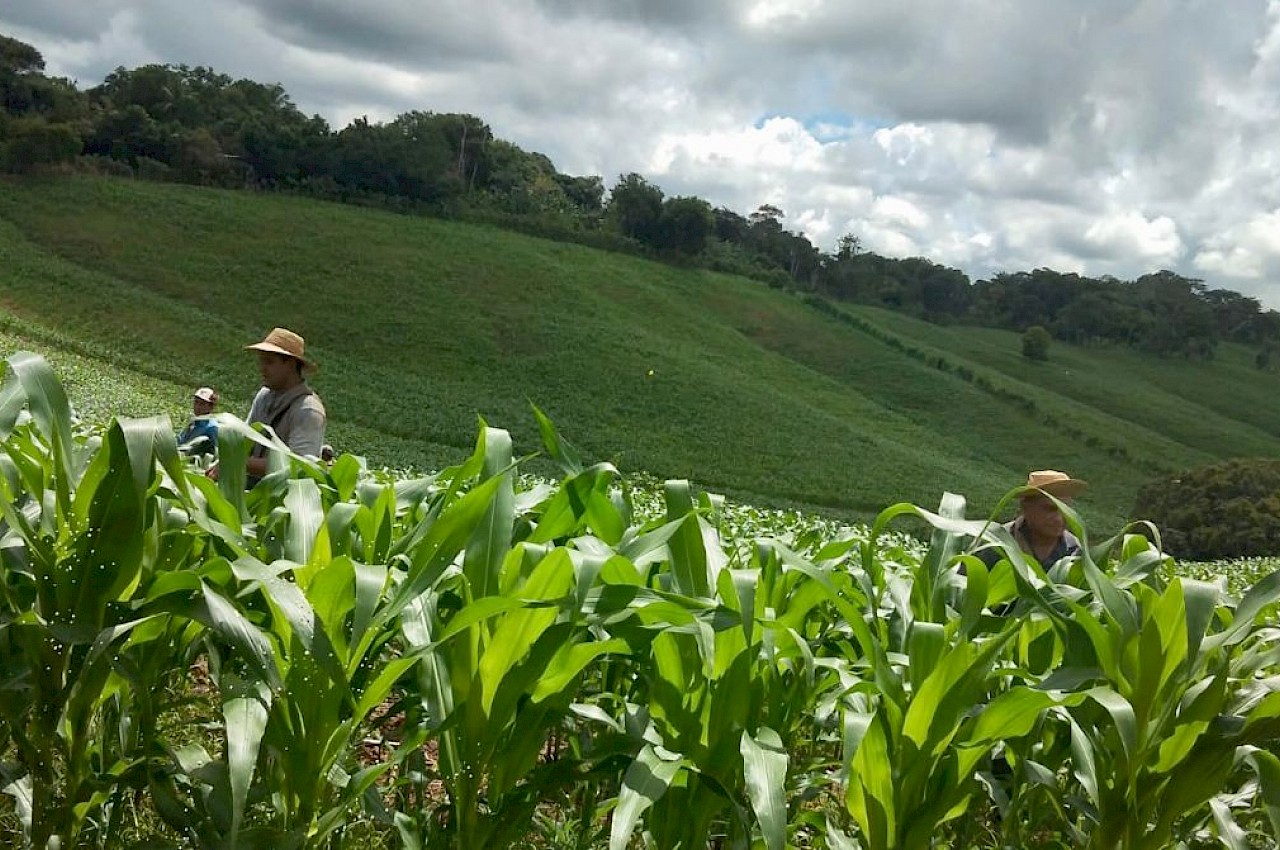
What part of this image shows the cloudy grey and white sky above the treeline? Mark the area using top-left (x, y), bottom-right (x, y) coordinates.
top-left (0, 0), bottom-right (1280, 309)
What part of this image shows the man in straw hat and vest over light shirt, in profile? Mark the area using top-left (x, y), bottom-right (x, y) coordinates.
top-left (244, 328), bottom-right (325, 485)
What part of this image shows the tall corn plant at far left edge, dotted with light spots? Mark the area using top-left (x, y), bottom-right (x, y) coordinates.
top-left (0, 355), bottom-right (259, 849)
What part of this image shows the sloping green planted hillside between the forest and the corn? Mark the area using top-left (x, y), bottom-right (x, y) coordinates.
top-left (0, 178), bottom-right (1280, 527)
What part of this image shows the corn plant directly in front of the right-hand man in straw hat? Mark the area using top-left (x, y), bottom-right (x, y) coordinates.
top-left (819, 494), bottom-right (1085, 850)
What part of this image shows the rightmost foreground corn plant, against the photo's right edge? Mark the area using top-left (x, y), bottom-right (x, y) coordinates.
top-left (1013, 535), bottom-right (1280, 850)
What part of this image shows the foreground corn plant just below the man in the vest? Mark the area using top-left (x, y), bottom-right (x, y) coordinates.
top-left (149, 431), bottom-right (504, 847)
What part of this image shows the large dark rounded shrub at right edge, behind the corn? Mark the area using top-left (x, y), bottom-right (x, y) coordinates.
top-left (1134, 458), bottom-right (1280, 561)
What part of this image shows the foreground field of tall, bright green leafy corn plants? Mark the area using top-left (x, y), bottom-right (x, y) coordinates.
top-left (0, 353), bottom-right (1280, 850)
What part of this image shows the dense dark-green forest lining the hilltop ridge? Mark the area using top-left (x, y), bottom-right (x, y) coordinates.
top-left (0, 35), bottom-right (1280, 358)
